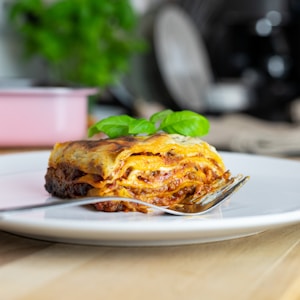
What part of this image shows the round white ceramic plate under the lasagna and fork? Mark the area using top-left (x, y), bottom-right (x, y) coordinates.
top-left (0, 151), bottom-right (300, 246)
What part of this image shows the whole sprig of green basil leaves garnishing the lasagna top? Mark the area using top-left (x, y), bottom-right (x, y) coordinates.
top-left (88, 109), bottom-right (209, 138)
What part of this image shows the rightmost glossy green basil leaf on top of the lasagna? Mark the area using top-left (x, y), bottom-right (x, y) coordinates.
top-left (159, 110), bottom-right (209, 136)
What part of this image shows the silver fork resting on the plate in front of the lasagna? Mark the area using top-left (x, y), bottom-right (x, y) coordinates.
top-left (0, 175), bottom-right (249, 218)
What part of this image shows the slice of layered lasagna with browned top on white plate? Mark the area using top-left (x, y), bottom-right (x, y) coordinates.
top-left (45, 133), bottom-right (230, 212)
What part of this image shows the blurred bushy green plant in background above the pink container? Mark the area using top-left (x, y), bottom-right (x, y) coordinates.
top-left (10, 0), bottom-right (142, 87)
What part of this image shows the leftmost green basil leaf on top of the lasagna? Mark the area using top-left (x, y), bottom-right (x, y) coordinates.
top-left (88, 115), bottom-right (135, 138)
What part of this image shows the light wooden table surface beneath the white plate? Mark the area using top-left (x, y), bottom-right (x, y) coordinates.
top-left (0, 149), bottom-right (300, 300)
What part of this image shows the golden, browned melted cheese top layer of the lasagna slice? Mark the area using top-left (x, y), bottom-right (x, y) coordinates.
top-left (49, 134), bottom-right (225, 179)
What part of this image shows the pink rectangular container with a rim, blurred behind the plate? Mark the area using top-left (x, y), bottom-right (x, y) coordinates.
top-left (0, 87), bottom-right (96, 147)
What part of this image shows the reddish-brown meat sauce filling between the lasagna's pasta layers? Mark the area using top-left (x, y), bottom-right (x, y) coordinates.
top-left (45, 151), bottom-right (227, 212)
